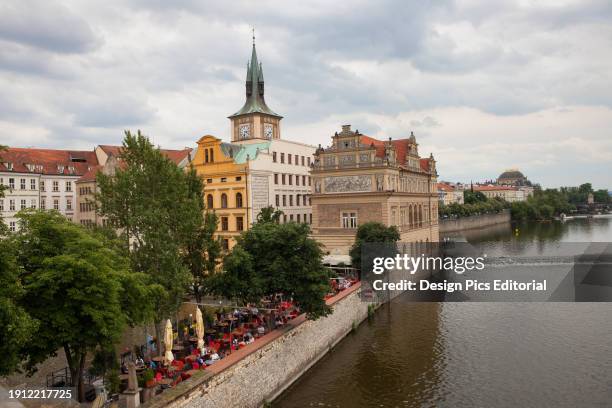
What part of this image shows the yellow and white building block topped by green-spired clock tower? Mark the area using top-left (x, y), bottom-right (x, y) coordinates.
top-left (192, 44), bottom-right (315, 250)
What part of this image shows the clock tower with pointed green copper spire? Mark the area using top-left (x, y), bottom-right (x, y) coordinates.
top-left (229, 36), bottom-right (283, 143)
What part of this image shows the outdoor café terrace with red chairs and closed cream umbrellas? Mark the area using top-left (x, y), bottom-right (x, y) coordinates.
top-left (113, 295), bottom-right (300, 402)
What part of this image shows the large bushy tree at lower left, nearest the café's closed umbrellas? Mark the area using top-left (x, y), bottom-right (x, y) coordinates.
top-left (12, 210), bottom-right (160, 401)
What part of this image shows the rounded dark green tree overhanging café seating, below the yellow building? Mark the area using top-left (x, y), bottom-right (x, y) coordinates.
top-left (210, 212), bottom-right (330, 319)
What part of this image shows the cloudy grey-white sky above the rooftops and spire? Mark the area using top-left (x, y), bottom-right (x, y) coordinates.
top-left (0, 0), bottom-right (612, 188)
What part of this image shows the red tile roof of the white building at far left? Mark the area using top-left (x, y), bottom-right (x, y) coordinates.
top-left (0, 147), bottom-right (98, 176)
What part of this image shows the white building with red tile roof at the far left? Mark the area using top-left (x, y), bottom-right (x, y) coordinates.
top-left (0, 147), bottom-right (98, 231)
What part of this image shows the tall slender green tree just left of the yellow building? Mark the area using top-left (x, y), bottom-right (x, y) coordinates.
top-left (96, 131), bottom-right (195, 350)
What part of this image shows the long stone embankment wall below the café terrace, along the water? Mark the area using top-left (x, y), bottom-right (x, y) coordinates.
top-left (145, 283), bottom-right (368, 408)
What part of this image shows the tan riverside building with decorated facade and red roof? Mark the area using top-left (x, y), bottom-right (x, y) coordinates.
top-left (311, 125), bottom-right (438, 253)
